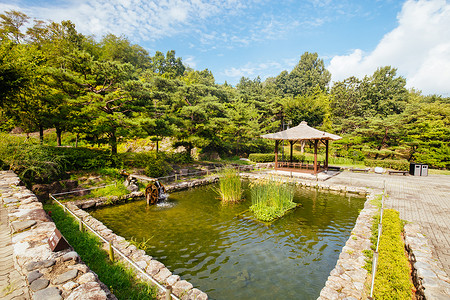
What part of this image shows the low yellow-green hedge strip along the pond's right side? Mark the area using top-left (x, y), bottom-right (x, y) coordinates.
top-left (374, 209), bottom-right (413, 300)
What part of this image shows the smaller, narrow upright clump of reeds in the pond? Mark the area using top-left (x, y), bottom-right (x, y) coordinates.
top-left (216, 168), bottom-right (242, 202)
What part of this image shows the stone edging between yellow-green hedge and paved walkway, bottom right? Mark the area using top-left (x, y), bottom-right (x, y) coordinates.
top-left (404, 223), bottom-right (450, 299)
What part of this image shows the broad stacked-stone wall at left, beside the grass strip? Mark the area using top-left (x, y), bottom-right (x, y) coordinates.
top-left (0, 171), bottom-right (112, 300)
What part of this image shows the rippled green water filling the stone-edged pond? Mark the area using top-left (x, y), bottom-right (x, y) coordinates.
top-left (91, 182), bottom-right (364, 299)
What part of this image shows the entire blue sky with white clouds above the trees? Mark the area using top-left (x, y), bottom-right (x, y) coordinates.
top-left (0, 0), bottom-right (450, 97)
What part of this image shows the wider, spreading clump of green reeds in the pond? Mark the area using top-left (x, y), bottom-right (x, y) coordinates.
top-left (249, 178), bottom-right (297, 222)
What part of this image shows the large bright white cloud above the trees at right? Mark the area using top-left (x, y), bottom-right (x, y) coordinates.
top-left (328, 0), bottom-right (450, 96)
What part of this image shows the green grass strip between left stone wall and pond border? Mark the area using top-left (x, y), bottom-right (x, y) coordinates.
top-left (45, 204), bottom-right (157, 300)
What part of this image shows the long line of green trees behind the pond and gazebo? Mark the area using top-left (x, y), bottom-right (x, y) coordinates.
top-left (0, 11), bottom-right (450, 168)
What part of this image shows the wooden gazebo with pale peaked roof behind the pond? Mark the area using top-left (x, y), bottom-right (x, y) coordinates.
top-left (261, 121), bottom-right (341, 175)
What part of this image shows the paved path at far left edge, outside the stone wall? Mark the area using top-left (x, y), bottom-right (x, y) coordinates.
top-left (0, 199), bottom-right (30, 300)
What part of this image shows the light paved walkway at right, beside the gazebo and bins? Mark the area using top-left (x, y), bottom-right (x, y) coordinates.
top-left (326, 171), bottom-right (450, 276)
